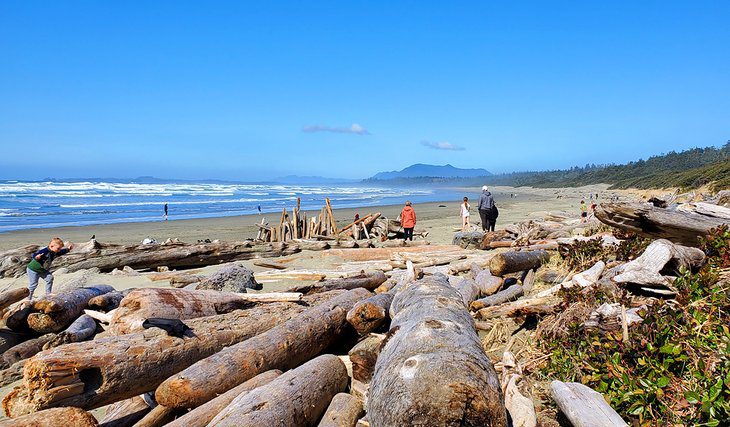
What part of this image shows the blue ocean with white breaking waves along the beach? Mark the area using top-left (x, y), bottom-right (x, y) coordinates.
top-left (0, 181), bottom-right (459, 232)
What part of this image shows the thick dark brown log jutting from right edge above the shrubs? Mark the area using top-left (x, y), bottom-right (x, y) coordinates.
top-left (596, 202), bottom-right (730, 246)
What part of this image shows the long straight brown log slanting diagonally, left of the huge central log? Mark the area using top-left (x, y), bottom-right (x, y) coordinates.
top-left (155, 288), bottom-right (372, 408)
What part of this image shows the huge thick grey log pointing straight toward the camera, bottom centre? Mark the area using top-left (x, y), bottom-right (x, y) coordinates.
top-left (367, 275), bottom-right (507, 426)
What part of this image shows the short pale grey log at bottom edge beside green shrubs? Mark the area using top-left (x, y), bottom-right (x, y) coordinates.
top-left (550, 381), bottom-right (628, 427)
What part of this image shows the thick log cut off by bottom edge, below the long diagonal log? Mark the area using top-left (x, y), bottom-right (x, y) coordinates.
top-left (209, 354), bottom-right (348, 427)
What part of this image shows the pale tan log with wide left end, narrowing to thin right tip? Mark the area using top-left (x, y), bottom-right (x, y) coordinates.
top-left (109, 288), bottom-right (301, 335)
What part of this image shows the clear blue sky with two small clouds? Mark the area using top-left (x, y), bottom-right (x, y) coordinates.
top-left (0, 0), bottom-right (730, 180)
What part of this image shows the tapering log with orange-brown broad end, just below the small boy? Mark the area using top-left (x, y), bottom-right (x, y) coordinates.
top-left (21, 285), bottom-right (114, 334)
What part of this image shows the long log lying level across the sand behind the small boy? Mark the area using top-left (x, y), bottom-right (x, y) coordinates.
top-left (0, 242), bottom-right (300, 277)
